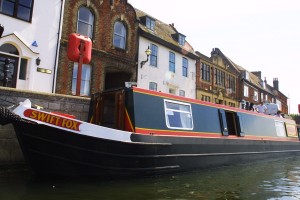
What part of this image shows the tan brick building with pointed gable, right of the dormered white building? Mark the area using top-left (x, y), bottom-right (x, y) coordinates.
top-left (196, 48), bottom-right (239, 107)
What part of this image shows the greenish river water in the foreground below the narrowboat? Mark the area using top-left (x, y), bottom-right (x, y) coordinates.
top-left (0, 157), bottom-right (300, 200)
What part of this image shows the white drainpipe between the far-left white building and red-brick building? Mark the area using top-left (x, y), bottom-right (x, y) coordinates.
top-left (52, 0), bottom-right (65, 93)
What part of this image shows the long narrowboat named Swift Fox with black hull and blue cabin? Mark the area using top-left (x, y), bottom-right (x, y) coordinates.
top-left (1, 87), bottom-right (300, 178)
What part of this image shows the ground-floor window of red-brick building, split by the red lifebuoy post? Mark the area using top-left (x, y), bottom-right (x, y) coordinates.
top-left (72, 63), bottom-right (91, 96)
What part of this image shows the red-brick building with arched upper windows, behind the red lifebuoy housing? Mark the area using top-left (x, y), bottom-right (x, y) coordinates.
top-left (56, 0), bottom-right (138, 96)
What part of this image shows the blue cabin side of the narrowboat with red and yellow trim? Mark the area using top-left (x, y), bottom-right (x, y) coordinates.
top-left (132, 88), bottom-right (298, 139)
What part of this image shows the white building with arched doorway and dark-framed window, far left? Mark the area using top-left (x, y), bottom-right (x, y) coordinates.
top-left (0, 0), bottom-right (64, 93)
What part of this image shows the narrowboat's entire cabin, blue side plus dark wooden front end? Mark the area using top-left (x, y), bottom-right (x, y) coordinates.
top-left (89, 87), bottom-right (298, 140)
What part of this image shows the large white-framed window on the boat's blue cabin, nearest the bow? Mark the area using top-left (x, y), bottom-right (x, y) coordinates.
top-left (164, 100), bottom-right (193, 130)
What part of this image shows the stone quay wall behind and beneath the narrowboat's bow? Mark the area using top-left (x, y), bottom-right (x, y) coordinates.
top-left (0, 87), bottom-right (90, 166)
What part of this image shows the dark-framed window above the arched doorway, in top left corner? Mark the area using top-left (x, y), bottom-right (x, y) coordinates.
top-left (0, 0), bottom-right (33, 22)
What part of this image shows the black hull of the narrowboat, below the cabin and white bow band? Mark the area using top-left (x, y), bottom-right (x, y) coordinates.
top-left (14, 121), bottom-right (300, 178)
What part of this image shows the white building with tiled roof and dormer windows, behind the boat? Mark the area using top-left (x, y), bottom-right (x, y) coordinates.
top-left (136, 9), bottom-right (197, 98)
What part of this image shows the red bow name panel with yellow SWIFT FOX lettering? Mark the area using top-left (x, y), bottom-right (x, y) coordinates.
top-left (24, 109), bottom-right (81, 131)
